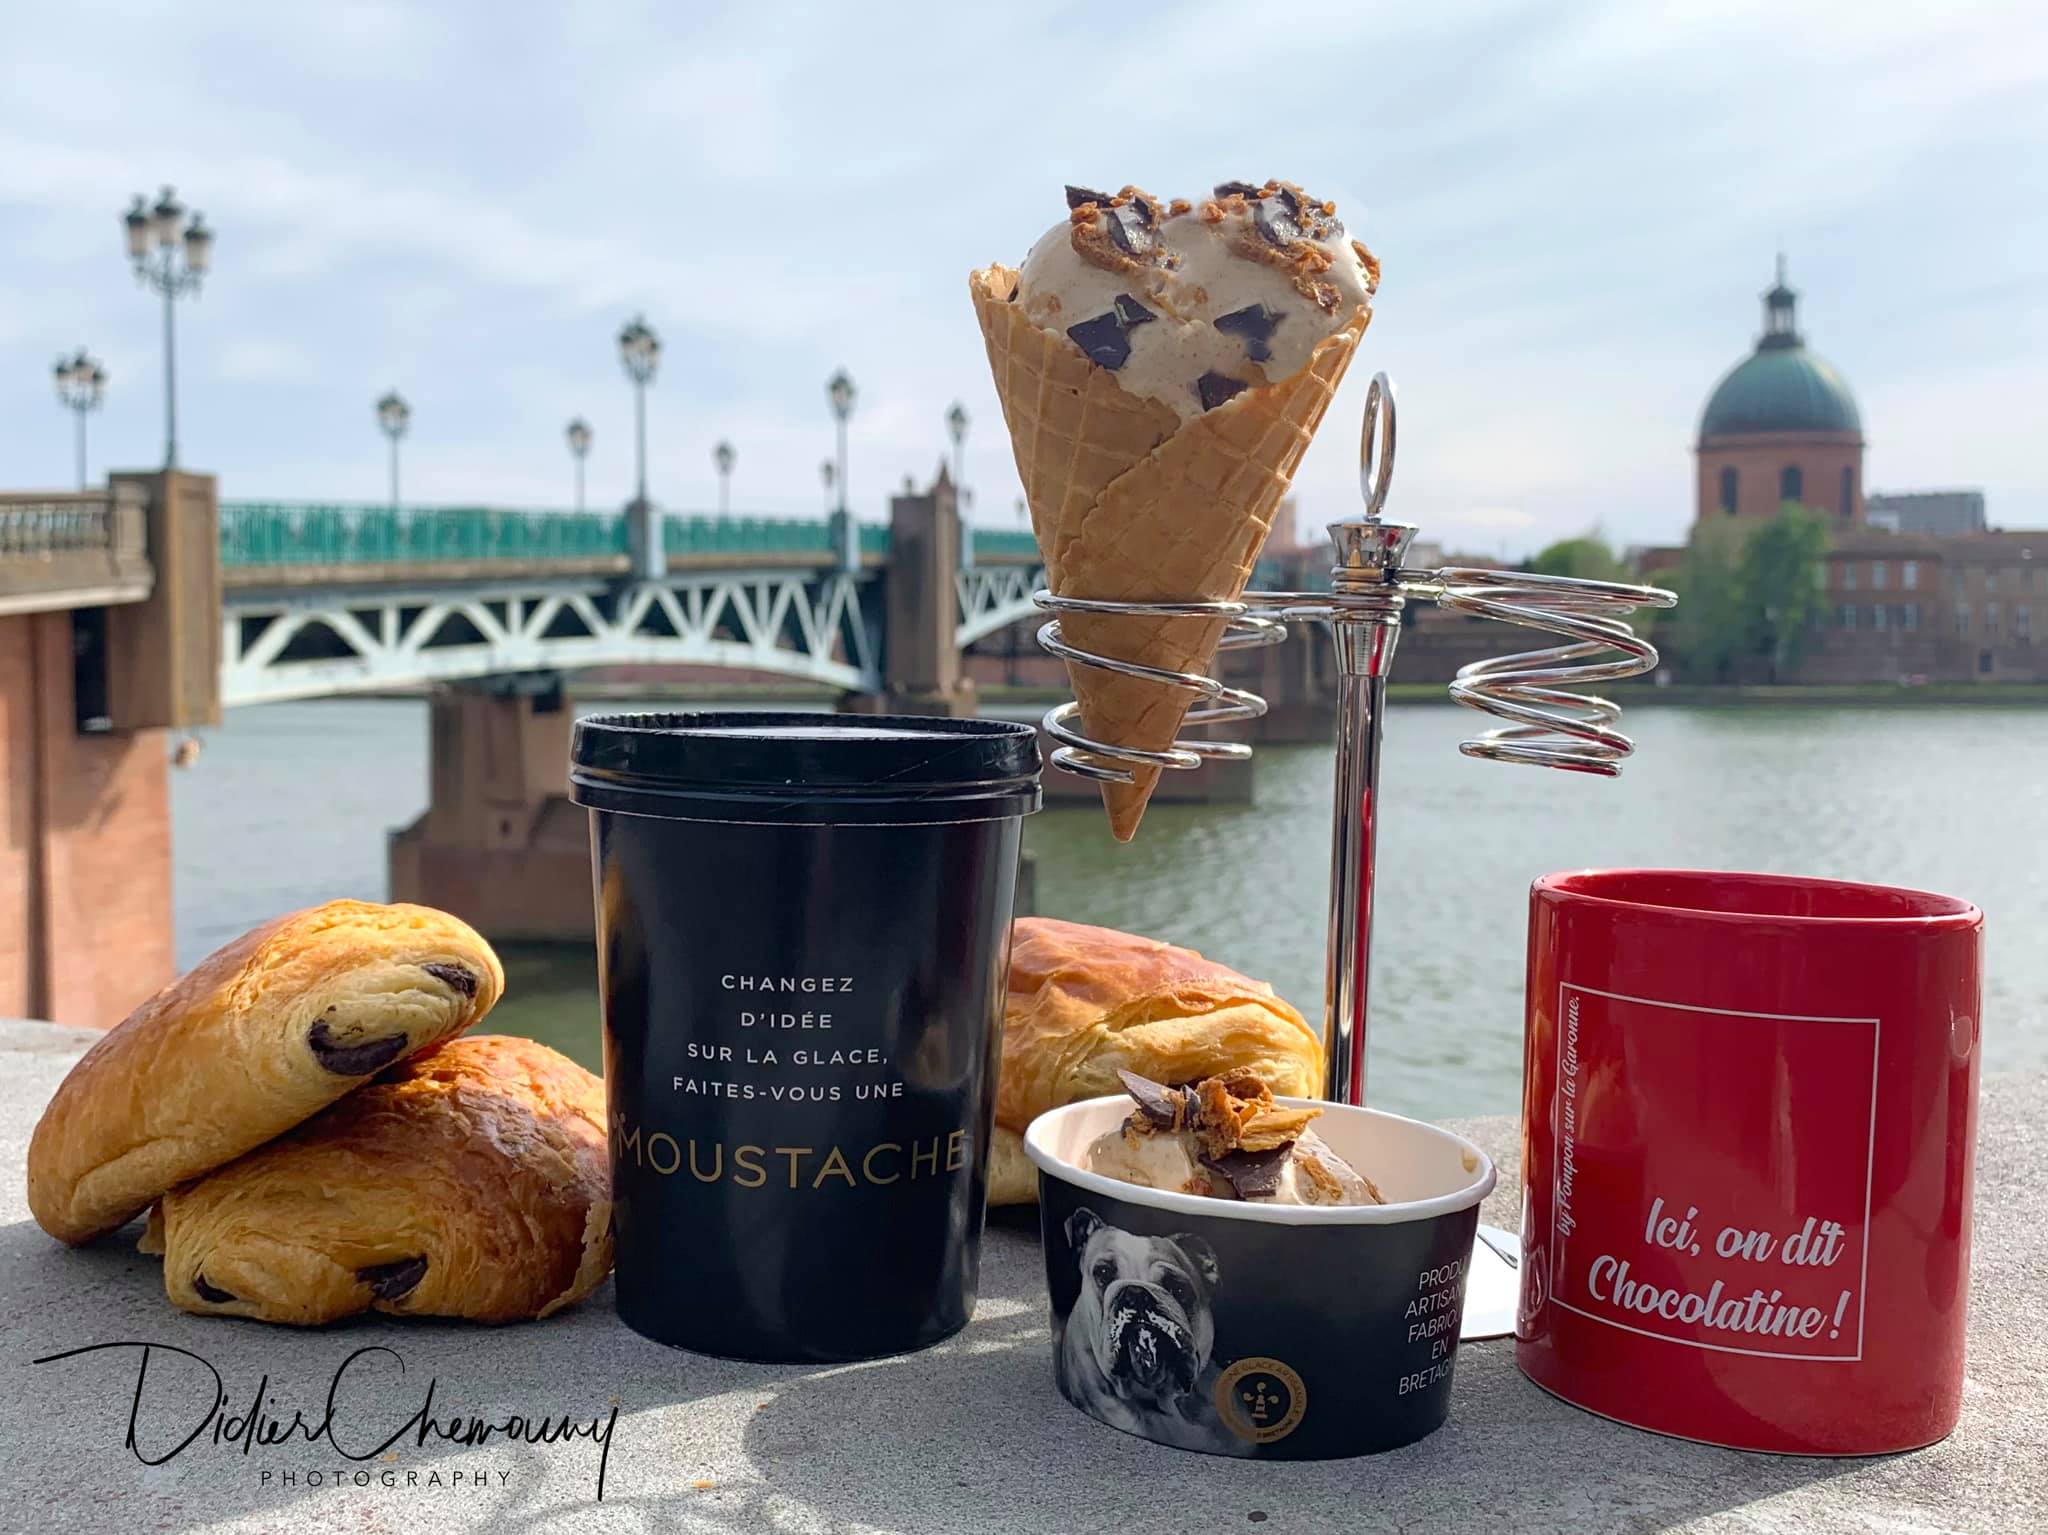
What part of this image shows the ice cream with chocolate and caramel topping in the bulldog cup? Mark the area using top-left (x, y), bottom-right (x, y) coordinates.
top-left (1081, 1072), bottom-right (1386, 1205)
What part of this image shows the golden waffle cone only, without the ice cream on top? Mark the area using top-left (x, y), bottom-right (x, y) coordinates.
top-left (969, 266), bottom-right (1370, 841)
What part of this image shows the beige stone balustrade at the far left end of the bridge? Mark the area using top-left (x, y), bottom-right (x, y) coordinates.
top-left (0, 485), bottom-right (156, 614)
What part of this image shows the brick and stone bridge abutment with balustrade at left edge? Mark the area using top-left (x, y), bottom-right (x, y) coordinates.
top-left (0, 471), bottom-right (221, 1027)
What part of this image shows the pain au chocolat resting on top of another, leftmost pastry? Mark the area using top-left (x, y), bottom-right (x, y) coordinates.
top-left (29, 901), bottom-right (504, 1242)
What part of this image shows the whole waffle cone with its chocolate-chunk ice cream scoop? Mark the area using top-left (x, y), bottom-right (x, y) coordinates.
top-left (969, 182), bottom-right (1378, 855)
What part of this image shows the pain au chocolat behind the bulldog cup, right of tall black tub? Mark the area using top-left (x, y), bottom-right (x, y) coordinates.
top-left (989, 917), bottom-right (1323, 1205)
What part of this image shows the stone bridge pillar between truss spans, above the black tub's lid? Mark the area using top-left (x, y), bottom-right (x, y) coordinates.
top-left (842, 465), bottom-right (975, 716)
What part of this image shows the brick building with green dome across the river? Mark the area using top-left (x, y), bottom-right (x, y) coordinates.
top-left (1687, 258), bottom-right (2048, 682)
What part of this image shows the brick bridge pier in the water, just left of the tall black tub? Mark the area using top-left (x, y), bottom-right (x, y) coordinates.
top-left (389, 675), bottom-right (592, 939)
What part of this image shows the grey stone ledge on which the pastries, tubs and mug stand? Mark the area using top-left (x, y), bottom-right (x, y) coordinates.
top-left (0, 1023), bottom-right (2048, 1535)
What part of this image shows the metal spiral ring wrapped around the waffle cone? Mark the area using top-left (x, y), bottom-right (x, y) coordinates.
top-left (1032, 589), bottom-right (1286, 784)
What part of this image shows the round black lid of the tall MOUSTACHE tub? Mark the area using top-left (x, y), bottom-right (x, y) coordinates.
top-left (569, 710), bottom-right (1038, 819)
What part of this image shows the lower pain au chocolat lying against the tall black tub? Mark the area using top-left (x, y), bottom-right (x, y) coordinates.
top-left (143, 1036), bottom-right (612, 1326)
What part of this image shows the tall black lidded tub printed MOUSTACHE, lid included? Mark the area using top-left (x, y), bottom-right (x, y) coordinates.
top-left (569, 712), bottom-right (1038, 1361)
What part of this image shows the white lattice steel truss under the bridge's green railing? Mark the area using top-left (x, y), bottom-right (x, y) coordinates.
top-left (221, 565), bottom-right (1038, 708)
